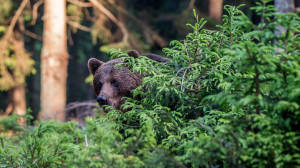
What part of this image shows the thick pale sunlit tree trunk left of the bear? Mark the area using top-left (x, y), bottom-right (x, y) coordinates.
top-left (41, 0), bottom-right (68, 121)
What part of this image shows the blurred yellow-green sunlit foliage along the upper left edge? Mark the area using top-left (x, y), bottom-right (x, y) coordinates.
top-left (0, 0), bottom-right (35, 91)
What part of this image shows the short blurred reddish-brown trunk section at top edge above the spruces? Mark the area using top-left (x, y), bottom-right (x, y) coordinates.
top-left (209, 0), bottom-right (223, 21)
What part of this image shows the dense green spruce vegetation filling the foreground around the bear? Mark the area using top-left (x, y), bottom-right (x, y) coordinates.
top-left (0, 0), bottom-right (300, 167)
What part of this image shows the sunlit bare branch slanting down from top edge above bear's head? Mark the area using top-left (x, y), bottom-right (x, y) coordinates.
top-left (89, 0), bottom-right (128, 42)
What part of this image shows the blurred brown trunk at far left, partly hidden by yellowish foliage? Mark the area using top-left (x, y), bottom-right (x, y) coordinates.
top-left (5, 16), bottom-right (26, 126)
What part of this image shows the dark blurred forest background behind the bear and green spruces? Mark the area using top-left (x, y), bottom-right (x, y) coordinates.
top-left (0, 0), bottom-right (300, 120)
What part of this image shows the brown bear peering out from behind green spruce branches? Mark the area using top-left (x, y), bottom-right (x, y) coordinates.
top-left (88, 50), bottom-right (170, 112)
